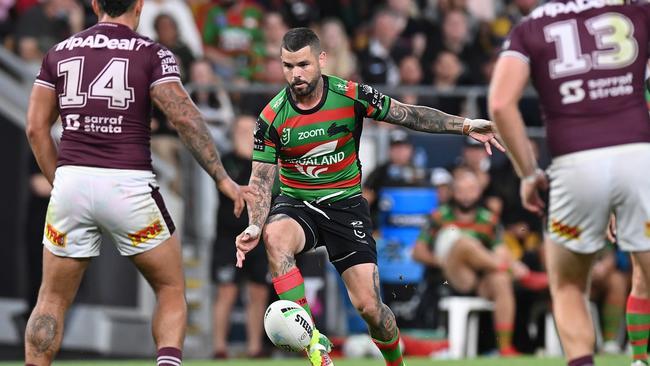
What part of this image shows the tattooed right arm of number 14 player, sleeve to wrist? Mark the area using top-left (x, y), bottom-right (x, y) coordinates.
top-left (151, 82), bottom-right (228, 182)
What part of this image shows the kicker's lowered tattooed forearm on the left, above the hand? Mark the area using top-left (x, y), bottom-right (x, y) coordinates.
top-left (248, 161), bottom-right (277, 228)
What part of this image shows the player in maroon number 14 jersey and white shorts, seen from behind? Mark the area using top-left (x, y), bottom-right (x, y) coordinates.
top-left (25, 0), bottom-right (243, 366)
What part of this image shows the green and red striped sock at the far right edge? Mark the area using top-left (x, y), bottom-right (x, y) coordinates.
top-left (625, 295), bottom-right (650, 365)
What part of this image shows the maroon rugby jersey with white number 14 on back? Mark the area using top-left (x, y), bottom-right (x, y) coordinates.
top-left (35, 23), bottom-right (180, 170)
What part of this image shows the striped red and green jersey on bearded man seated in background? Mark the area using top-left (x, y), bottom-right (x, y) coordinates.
top-left (418, 205), bottom-right (499, 248)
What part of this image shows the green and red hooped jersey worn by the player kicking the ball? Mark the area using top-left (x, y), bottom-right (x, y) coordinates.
top-left (253, 75), bottom-right (391, 203)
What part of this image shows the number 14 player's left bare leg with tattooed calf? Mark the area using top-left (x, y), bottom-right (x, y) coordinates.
top-left (25, 249), bottom-right (90, 366)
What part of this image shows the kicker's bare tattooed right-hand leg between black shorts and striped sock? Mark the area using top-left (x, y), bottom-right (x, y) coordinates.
top-left (341, 263), bottom-right (397, 341)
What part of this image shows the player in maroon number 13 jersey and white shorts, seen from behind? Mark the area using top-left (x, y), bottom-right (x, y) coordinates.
top-left (489, 0), bottom-right (650, 366)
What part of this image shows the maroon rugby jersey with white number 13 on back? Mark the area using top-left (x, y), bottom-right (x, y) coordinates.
top-left (502, 0), bottom-right (650, 156)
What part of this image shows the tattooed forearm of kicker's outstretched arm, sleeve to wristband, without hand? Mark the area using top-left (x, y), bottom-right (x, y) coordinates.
top-left (384, 99), bottom-right (465, 135)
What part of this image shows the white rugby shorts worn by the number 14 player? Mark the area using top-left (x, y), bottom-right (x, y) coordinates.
top-left (43, 165), bottom-right (175, 258)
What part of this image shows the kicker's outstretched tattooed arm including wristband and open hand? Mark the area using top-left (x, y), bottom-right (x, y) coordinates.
top-left (384, 99), bottom-right (505, 154)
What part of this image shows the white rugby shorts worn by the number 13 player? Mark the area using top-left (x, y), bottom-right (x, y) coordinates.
top-left (548, 143), bottom-right (650, 253)
